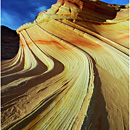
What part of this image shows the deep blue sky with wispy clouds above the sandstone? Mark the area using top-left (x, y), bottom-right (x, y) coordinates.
top-left (1, 0), bottom-right (129, 30)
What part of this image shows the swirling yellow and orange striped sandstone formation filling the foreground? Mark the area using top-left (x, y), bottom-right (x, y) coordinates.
top-left (1, 0), bottom-right (129, 130)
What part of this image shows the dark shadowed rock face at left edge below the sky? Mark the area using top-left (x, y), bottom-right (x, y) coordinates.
top-left (1, 26), bottom-right (19, 60)
